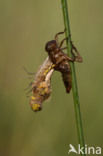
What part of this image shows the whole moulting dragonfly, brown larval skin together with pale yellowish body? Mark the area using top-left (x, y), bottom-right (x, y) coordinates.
top-left (30, 29), bottom-right (82, 112)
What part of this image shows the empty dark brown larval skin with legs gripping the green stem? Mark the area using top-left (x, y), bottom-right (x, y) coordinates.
top-left (45, 32), bottom-right (82, 93)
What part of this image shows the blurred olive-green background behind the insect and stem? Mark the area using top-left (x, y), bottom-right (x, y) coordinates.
top-left (0, 0), bottom-right (103, 156)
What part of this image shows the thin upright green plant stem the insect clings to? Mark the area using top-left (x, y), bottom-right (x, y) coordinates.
top-left (61, 0), bottom-right (86, 156)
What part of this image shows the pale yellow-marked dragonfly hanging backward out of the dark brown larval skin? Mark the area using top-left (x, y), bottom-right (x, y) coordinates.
top-left (29, 57), bottom-right (55, 112)
